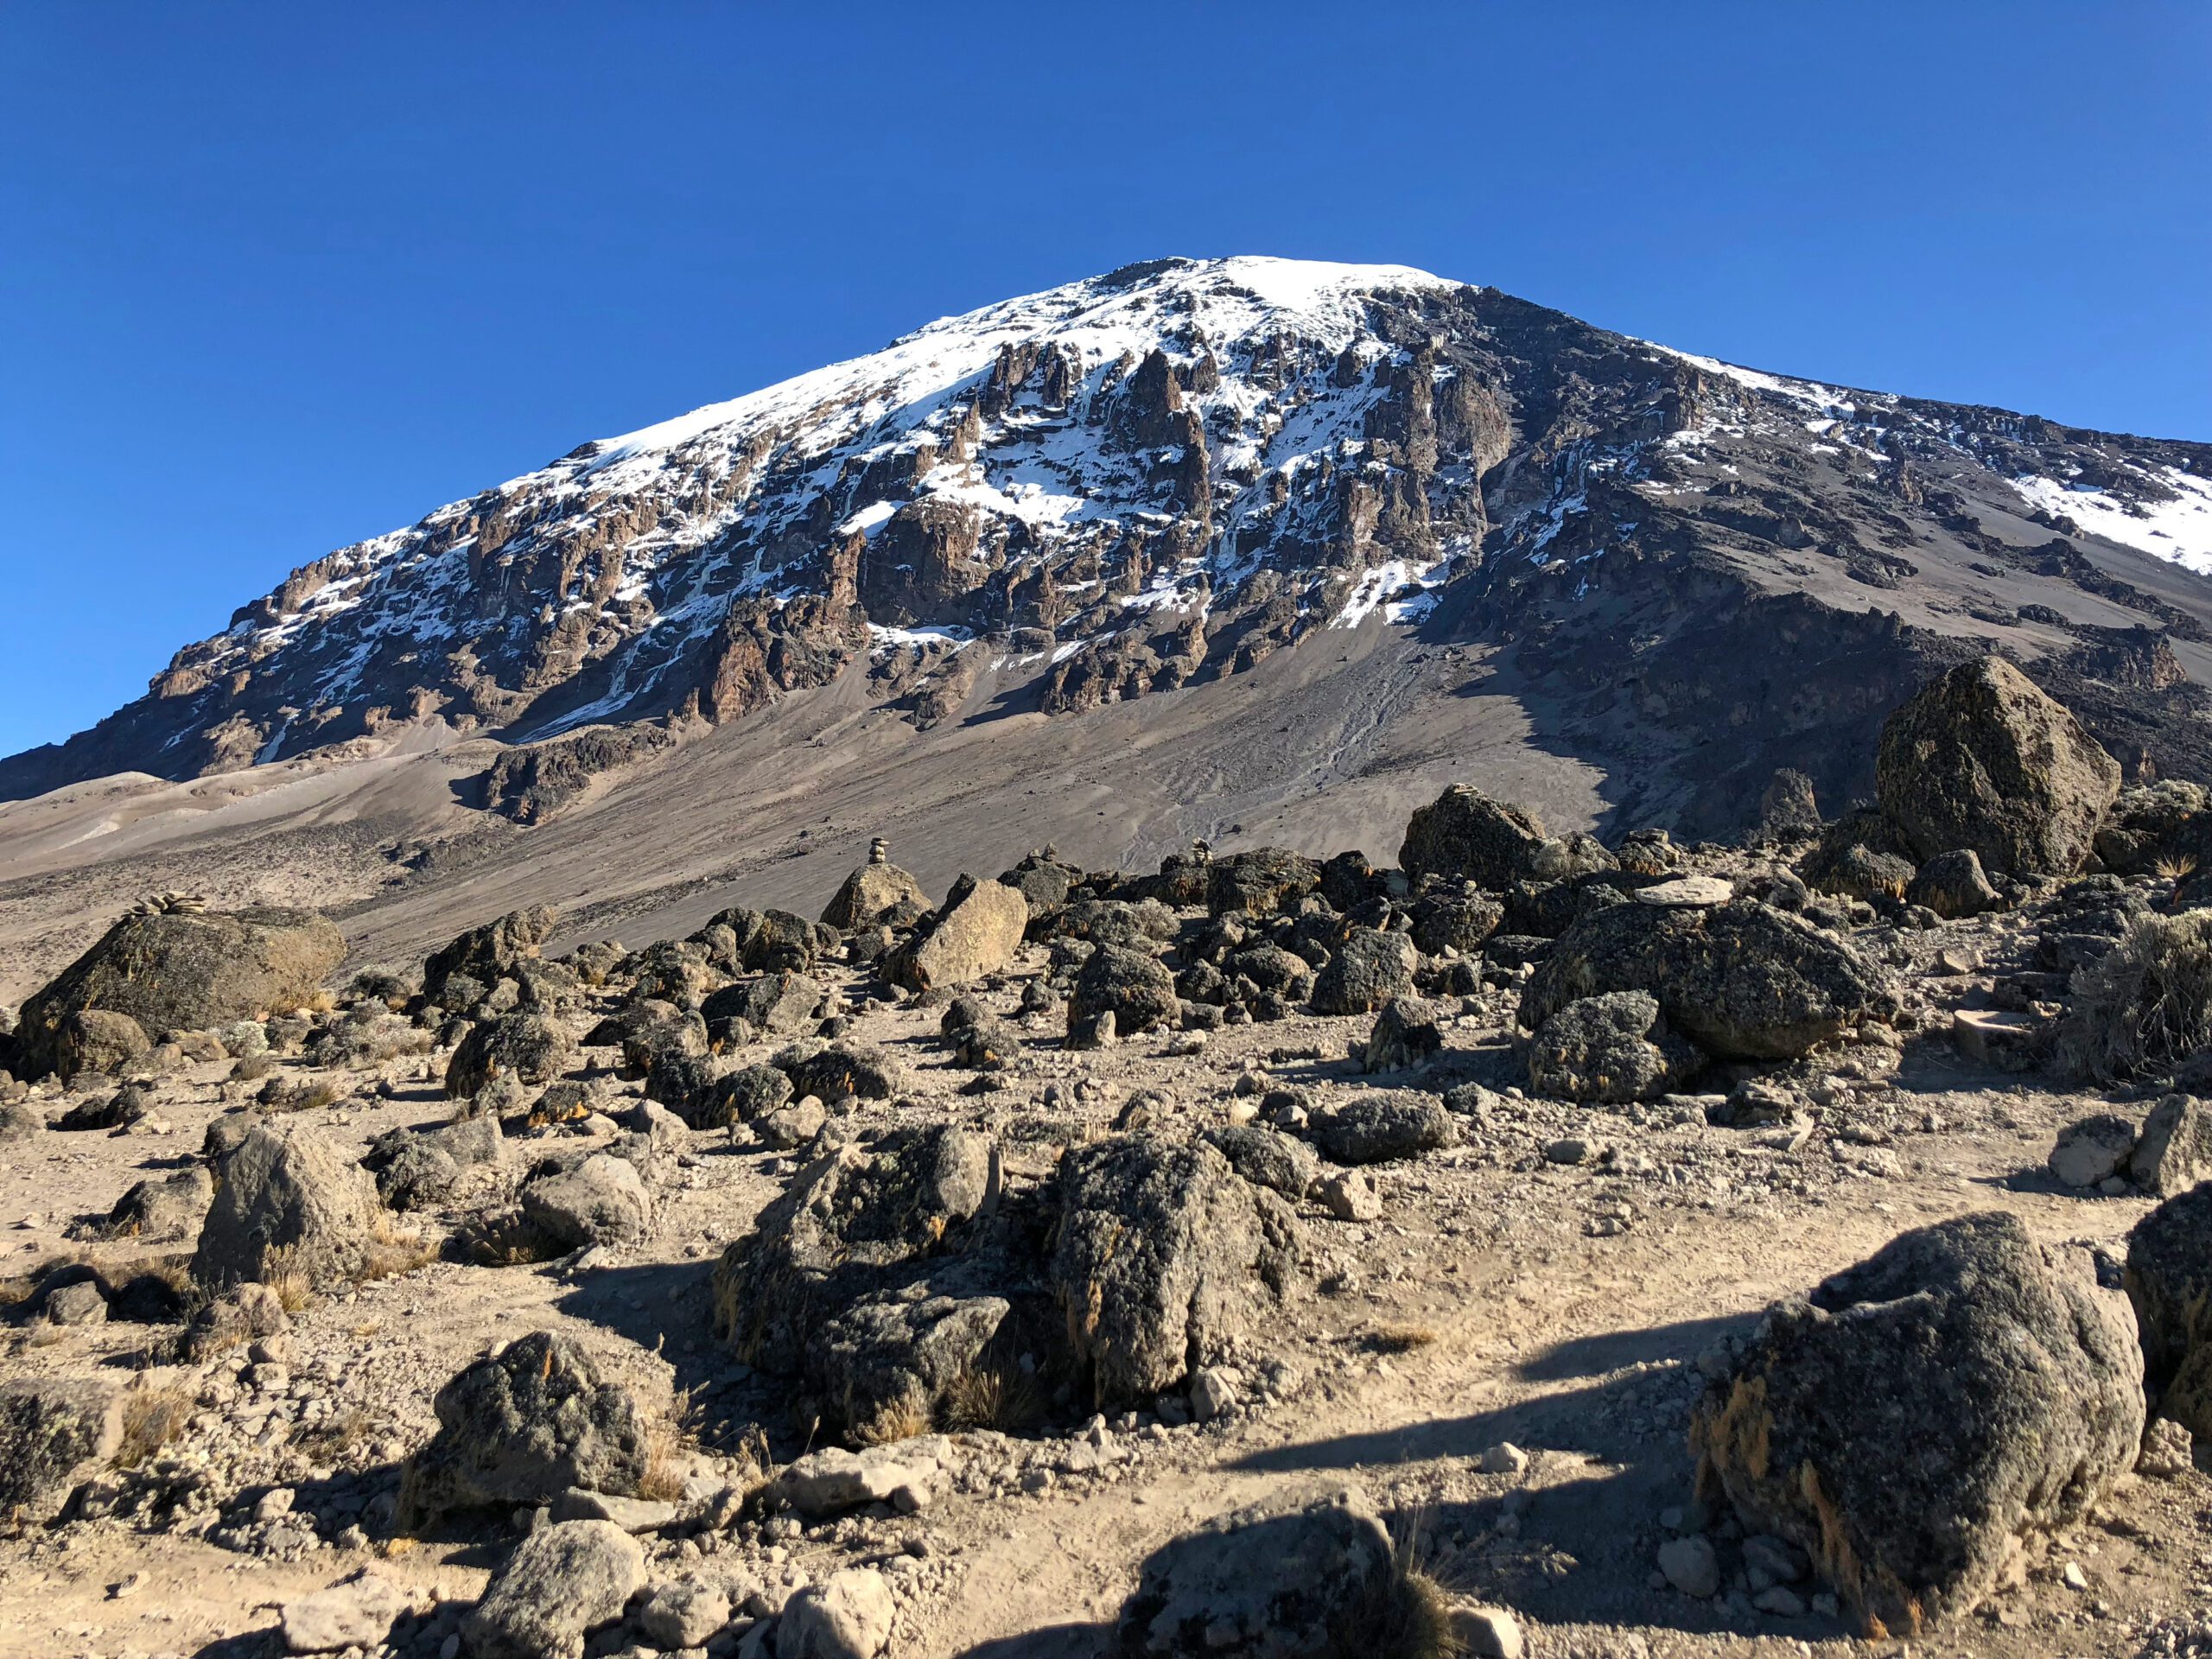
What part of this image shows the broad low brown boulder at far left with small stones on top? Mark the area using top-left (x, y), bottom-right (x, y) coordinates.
top-left (16, 907), bottom-right (345, 1077)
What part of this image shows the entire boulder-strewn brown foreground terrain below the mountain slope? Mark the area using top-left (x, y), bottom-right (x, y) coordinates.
top-left (0, 659), bottom-right (2212, 1659)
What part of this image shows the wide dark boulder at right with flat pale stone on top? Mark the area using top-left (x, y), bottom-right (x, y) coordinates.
top-left (1520, 898), bottom-right (1891, 1059)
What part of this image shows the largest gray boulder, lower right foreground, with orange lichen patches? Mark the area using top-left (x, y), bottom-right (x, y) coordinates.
top-left (1690, 1212), bottom-right (2144, 1635)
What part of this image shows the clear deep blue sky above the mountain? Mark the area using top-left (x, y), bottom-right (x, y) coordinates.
top-left (0, 0), bottom-right (2212, 754)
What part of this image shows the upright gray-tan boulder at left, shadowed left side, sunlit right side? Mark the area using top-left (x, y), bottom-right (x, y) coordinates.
top-left (193, 1122), bottom-right (380, 1292)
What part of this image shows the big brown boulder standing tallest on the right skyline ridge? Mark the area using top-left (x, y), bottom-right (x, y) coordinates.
top-left (1873, 657), bottom-right (2119, 876)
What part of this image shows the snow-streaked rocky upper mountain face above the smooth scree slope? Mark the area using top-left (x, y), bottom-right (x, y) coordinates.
top-left (13, 259), bottom-right (2212, 827)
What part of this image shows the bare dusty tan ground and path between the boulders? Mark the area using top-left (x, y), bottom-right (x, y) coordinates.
top-left (0, 854), bottom-right (2212, 1659)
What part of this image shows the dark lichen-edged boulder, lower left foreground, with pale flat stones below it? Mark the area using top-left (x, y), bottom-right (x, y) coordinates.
top-left (400, 1332), bottom-right (651, 1524)
